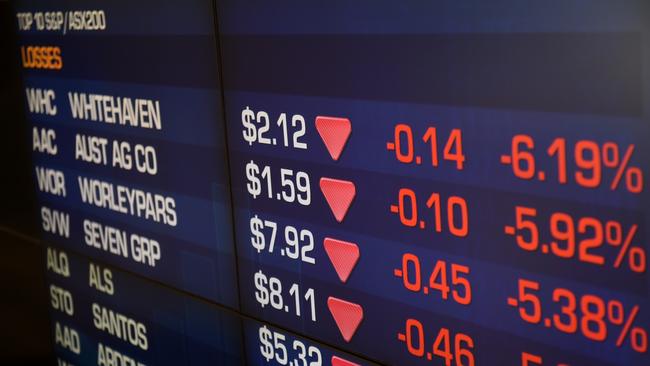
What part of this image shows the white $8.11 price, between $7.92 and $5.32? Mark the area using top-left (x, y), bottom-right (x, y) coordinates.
top-left (254, 270), bottom-right (316, 322)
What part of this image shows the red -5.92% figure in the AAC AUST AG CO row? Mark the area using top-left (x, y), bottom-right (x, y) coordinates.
top-left (504, 206), bottom-right (647, 273)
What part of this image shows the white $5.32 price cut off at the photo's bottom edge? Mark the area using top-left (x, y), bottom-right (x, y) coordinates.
top-left (259, 325), bottom-right (323, 366)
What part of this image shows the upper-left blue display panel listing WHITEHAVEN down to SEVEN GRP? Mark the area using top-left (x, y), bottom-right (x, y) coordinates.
top-left (15, 0), bottom-right (237, 307)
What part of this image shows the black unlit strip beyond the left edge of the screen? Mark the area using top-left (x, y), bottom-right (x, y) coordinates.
top-left (0, 1), bottom-right (53, 365)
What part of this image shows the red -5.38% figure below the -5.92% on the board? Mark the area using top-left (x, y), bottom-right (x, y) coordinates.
top-left (507, 279), bottom-right (648, 353)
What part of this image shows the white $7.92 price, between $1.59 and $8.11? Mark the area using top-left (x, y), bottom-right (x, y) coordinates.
top-left (250, 215), bottom-right (316, 264)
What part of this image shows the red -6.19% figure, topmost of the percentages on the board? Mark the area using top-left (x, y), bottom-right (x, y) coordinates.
top-left (501, 134), bottom-right (643, 194)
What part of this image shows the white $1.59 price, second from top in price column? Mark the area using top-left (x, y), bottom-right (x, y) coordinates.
top-left (246, 160), bottom-right (311, 206)
